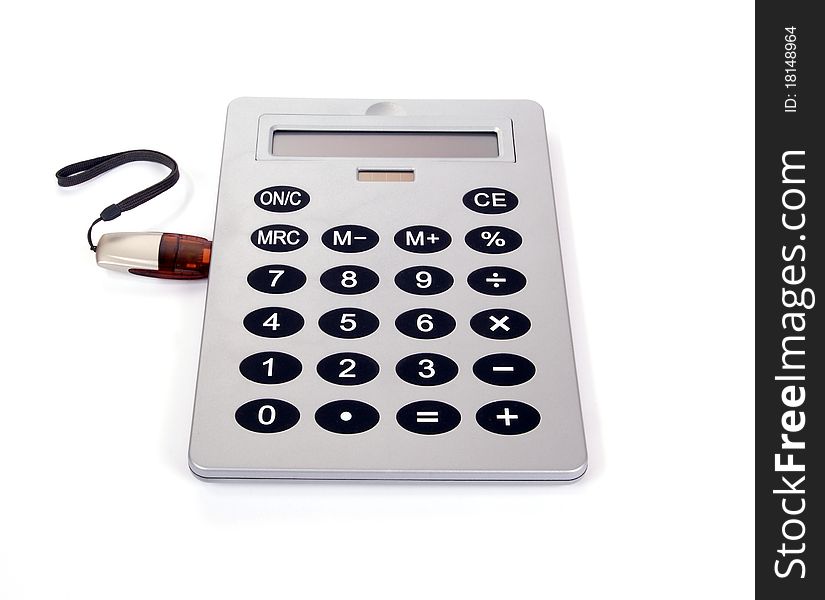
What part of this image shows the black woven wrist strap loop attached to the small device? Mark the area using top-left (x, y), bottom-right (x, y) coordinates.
top-left (55, 150), bottom-right (180, 252)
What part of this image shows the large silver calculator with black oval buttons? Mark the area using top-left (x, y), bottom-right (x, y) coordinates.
top-left (189, 98), bottom-right (587, 481)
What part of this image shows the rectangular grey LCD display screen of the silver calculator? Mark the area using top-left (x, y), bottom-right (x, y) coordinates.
top-left (272, 130), bottom-right (499, 158)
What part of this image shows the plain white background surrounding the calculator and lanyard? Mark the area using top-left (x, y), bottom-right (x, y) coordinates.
top-left (0, 0), bottom-right (754, 599)
